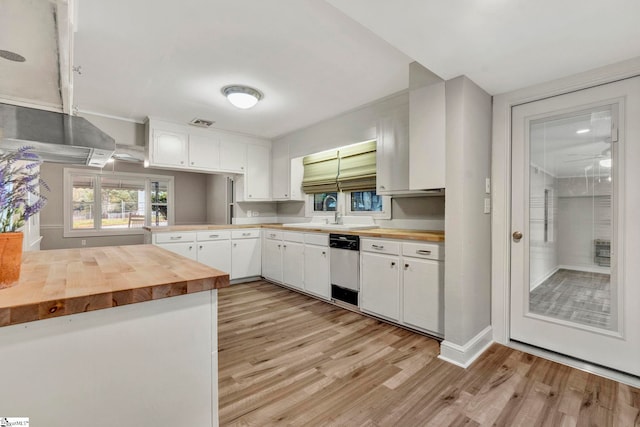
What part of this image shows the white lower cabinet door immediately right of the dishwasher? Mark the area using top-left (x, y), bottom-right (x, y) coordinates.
top-left (360, 252), bottom-right (400, 321)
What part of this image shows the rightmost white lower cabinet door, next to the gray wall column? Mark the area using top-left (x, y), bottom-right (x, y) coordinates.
top-left (402, 258), bottom-right (444, 334)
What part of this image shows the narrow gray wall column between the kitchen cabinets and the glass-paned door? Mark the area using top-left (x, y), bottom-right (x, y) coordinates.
top-left (445, 77), bottom-right (491, 346)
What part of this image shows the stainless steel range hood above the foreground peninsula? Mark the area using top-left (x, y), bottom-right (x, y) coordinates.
top-left (0, 104), bottom-right (116, 167)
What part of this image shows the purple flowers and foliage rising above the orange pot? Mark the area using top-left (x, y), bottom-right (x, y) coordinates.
top-left (0, 147), bottom-right (50, 233)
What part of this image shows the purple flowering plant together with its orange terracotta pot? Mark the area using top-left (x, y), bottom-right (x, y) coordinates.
top-left (0, 147), bottom-right (49, 289)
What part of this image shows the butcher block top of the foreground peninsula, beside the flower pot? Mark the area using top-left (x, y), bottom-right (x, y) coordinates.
top-left (0, 245), bottom-right (229, 326)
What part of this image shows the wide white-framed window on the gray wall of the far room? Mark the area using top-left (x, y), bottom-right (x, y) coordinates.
top-left (64, 168), bottom-right (173, 237)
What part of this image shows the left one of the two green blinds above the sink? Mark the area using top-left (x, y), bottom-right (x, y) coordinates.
top-left (302, 150), bottom-right (338, 194)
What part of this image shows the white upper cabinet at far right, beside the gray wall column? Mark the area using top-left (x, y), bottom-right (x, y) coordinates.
top-left (409, 81), bottom-right (446, 190)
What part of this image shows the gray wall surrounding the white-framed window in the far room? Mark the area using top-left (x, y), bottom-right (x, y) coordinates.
top-left (40, 161), bottom-right (207, 249)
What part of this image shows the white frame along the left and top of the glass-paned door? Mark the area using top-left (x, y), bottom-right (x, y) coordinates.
top-left (491, 57), bottom-right (640, 368)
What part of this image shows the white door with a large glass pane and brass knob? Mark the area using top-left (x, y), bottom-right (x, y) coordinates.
top-left (510, 78), bottom-right (640, 375)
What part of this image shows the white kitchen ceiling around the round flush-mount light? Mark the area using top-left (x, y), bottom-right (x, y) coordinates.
top-left (0, 0), bottom-right (640, 142)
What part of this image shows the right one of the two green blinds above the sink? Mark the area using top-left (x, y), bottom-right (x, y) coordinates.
top-left (338, 141), bottom-right (376, 191)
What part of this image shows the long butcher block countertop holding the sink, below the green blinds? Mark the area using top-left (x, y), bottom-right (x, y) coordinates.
top-left (145, 224), bottom-right (444, 242)
